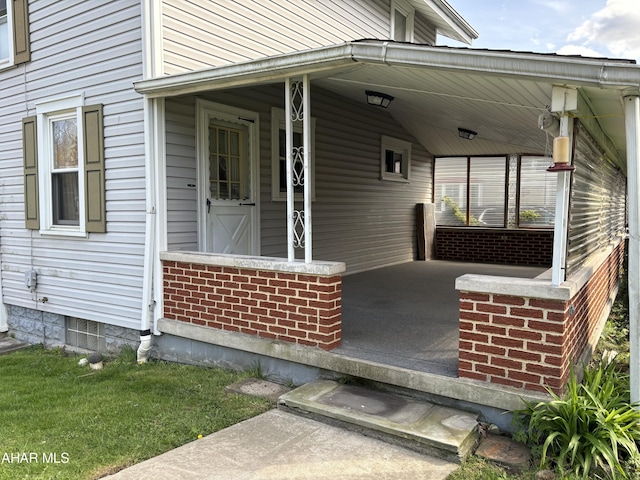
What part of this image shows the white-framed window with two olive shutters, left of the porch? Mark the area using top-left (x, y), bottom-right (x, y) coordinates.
top-left (22, 99), bottom-right (107, 236)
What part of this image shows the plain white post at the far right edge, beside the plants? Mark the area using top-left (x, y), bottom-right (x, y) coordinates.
top-left (624, 96), bottom-right (640, 402)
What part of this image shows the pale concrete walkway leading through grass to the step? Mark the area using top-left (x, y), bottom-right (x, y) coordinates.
top-left (105, 410), bottom-right (458, 480)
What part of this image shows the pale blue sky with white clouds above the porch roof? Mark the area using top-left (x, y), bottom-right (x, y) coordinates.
top-left (438, 0), bottom-right (640, 63)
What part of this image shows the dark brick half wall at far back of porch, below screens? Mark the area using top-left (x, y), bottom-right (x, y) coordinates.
top-left (436, 227), bottom-right (553, 267)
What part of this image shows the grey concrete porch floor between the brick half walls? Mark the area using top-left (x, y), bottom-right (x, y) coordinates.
top-left (333, 260), bottom-right (547, 377)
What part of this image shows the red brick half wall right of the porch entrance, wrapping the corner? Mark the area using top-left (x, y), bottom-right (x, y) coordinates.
top-left (458, 242), bottom-right (624, 393)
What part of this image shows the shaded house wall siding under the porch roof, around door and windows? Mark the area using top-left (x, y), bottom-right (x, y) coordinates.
top-left (167, 83), bottom-right (432, 272)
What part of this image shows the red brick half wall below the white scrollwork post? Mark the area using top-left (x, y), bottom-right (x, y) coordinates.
top-left (163, 255), bottom-right (342, 350)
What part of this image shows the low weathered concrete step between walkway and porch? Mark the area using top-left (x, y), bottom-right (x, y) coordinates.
top-left (278, 380), bottom-right (479, 462)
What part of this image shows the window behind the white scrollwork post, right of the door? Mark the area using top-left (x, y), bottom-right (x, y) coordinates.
top-left (271, 108), bottom-right (316, 201)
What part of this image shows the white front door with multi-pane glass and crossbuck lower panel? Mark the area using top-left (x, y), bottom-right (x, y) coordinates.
top-left (199, 102), bottom-right (259, 255)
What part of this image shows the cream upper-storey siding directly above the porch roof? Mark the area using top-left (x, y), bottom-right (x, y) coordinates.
top-left (162, 0), bottom-right (390, 74)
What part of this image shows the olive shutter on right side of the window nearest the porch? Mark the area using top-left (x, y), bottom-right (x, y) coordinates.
top-left (82, 105), bottom-right (107, 233)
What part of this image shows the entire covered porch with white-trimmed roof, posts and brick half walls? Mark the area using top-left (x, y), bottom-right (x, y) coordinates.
top-left (136, 41), bottom-right (633, 401)
